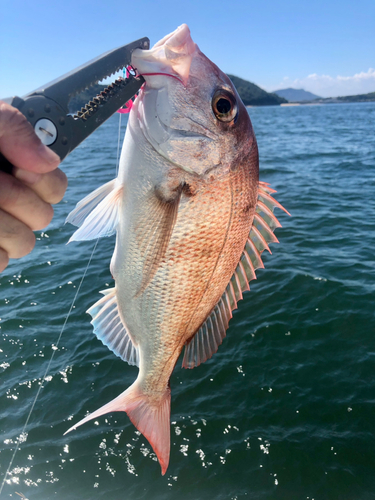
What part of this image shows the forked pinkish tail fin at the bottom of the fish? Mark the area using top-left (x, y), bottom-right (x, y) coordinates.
top-left (64, 382), bottom-right (171, 476)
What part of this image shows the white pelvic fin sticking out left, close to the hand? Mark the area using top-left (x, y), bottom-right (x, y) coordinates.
top-left (65, 179), bottom-right (123, 243)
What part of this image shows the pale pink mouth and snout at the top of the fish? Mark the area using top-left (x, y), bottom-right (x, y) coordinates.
top-left (131, 24), bottom-right (197, 87)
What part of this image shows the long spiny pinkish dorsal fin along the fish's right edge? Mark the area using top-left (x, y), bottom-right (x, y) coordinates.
top-left (182, 182), bottom-right (290, 368)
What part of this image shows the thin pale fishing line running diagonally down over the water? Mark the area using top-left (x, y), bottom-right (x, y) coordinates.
top-left (0, 113), bottom-right (121, 495)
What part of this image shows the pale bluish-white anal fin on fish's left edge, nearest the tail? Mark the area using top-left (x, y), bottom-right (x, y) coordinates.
top-left (87, 288), bottom-right (139, 366)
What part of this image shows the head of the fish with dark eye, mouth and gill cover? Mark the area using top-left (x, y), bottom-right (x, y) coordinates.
top-left (130, 24), bottom-right (258, 180)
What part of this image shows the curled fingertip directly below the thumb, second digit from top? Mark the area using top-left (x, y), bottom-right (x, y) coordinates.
top-left (13, 168), bottom-right (68, 204)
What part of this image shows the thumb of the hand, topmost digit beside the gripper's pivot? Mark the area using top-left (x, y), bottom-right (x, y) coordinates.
top-left (0, 101), bottom-right (60, 173)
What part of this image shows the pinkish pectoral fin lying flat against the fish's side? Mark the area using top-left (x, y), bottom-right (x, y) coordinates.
top-left (135, 185), bottom-right (183, 296)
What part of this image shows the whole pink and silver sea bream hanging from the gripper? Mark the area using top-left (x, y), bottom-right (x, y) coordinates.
top-left (67, 24), bottom-right (288, 475)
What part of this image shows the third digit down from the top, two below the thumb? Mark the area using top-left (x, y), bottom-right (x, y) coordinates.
top-left (0, 172), bottom-right (53, 229)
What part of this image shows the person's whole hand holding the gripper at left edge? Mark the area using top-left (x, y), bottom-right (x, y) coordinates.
top-left (0, 101), bottom-right (68, 272)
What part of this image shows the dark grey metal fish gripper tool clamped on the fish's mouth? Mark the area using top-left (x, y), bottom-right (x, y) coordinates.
top-left (0, 37), bottom-right (150, 174)
